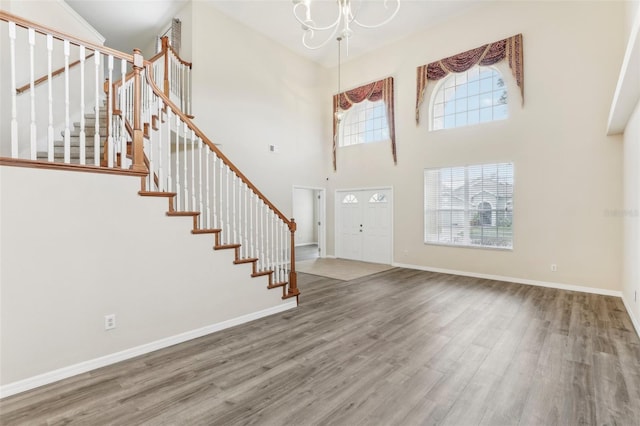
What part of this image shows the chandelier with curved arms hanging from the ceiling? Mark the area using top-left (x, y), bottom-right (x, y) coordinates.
top-left (293, 0), bottom-right (400, 50)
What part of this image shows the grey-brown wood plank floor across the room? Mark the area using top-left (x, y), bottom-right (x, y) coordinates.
top-left (0, 269), bottom-right (640, 426)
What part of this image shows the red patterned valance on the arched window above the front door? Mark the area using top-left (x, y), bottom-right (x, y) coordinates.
top-left (333, 77), bottom-right (398, 170)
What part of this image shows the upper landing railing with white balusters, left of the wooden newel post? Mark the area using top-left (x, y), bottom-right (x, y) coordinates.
top-left (0, 11), bottom-right (146, 172)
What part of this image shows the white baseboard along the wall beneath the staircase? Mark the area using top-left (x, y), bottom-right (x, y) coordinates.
top-left (0, 299), bottom-right (297, 399)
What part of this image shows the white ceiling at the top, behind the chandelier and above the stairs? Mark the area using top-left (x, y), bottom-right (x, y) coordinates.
top-left (67, 0), bottom-right (483, 67)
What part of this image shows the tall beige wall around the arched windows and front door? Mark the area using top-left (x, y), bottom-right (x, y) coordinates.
top-left (325, 2), bottom-right (624, 291)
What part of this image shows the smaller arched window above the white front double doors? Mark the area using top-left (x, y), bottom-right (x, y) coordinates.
top-left (339, 100), bottom-right (389, 146)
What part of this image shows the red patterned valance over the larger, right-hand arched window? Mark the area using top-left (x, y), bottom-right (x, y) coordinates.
top-left (416, 34), bottom-right (524, 124)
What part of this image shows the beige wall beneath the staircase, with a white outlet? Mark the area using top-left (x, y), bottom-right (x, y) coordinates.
top-left (0, 166), bottom-right (295, 386)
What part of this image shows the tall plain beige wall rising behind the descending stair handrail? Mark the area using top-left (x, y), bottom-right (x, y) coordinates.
top-left (188, 2), bottom-right (330, 216)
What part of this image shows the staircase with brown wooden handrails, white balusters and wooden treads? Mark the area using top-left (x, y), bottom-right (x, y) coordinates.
top-left (0, 10), bottom-right (299, 300)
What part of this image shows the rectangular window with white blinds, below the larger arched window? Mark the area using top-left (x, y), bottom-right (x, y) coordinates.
top-left (423, 162), bottom-right (515, 250)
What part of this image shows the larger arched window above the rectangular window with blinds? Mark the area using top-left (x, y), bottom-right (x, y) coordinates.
top-left (429, 65), bottom-right (509, 130)
